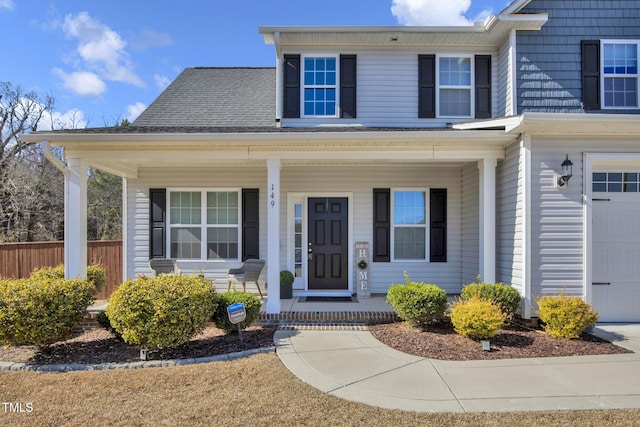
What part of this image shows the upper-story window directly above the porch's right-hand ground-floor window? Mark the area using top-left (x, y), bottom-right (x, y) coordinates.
top-left (437, 56), bottom-right (473, 117)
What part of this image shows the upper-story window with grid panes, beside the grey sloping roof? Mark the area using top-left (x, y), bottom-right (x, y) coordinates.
top-left (302, 56), bottom-right (338, 117)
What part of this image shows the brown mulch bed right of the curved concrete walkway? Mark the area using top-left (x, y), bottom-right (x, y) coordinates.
top-left (369, 320), bottom-right (632, 360)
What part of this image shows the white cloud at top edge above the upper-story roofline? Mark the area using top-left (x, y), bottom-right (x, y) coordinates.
top-left (391, 0), bottom-right (490, 26)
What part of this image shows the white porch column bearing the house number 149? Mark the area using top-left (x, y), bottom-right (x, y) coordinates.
top-left (267, 159), bottom-right (280, 314)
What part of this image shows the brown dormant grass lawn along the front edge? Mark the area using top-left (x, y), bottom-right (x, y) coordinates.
top-left (0, 354), bottom-right (640, 427)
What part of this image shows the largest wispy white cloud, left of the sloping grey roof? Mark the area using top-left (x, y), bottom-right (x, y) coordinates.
top-left (62, 12), bottom-right (144, 86)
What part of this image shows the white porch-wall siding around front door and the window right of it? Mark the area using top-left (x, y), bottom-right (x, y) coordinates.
top-left (280, 165), bottom-right (462, 293)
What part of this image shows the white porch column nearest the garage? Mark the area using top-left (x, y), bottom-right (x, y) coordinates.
top-left (478, 158), bottom-right (498, 283)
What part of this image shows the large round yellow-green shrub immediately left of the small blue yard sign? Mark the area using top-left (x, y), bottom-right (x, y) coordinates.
top-left (105, 274), bottom-right (216, 349)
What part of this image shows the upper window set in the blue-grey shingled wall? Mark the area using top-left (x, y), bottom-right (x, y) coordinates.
top-left (601, 40), bottom-right (640, 108)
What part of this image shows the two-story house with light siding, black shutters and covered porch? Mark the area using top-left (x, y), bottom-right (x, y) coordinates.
top-left (24, 0), bottom-right (640, 321)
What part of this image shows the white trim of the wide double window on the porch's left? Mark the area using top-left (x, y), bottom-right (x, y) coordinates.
top-left (165, 187), bottom-right (242, 263)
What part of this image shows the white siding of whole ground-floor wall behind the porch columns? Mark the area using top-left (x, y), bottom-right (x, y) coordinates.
top-left (126, 162), bottom-right (478, 293)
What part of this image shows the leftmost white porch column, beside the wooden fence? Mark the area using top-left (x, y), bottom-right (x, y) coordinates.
top-left (64, 159), bottom-right (88, 279)
